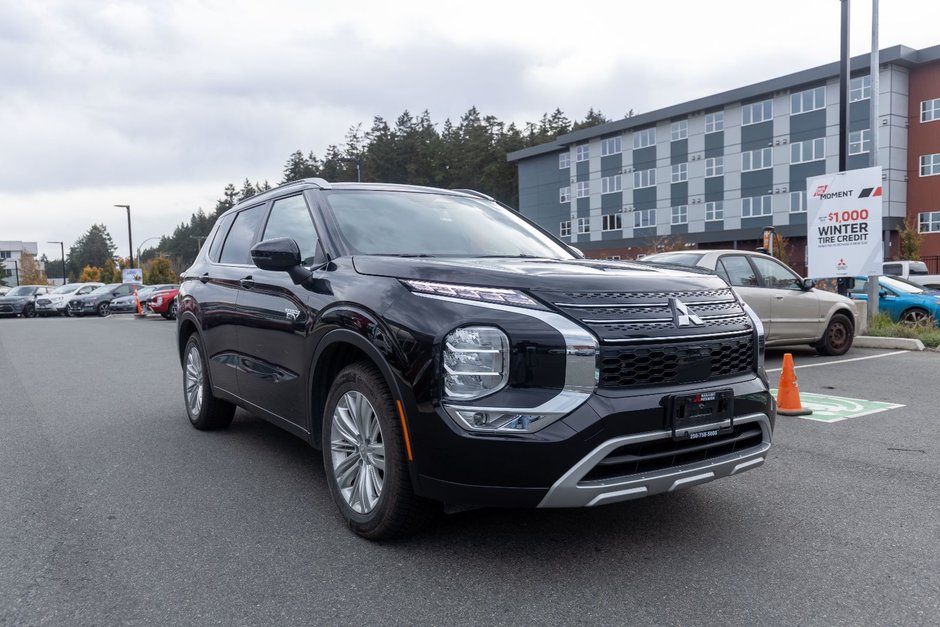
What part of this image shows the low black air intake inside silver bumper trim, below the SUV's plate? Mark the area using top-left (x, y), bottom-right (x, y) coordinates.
top-left (581, 422), bottom-right (763, 483)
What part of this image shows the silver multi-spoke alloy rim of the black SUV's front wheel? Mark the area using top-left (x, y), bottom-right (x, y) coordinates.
top-left (330, 390), bottom-right (385, 514)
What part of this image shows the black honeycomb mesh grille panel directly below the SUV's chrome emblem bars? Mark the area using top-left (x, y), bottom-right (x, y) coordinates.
top-left (598, 334), bottom-right (754, 389)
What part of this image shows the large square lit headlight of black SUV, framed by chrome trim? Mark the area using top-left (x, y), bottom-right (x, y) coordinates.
top-left (444, 327), bottom-right (509, 401)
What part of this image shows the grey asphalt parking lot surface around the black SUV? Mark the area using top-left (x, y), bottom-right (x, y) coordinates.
top-left (0, 316), bottom-right (940, 625)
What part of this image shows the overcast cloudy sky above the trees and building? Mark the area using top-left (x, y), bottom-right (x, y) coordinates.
top-left (0, 0), bottom-right (940, 257)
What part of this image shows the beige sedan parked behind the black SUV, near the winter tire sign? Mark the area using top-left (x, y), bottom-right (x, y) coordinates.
top-left (643, 250), bottom-right (858, 355)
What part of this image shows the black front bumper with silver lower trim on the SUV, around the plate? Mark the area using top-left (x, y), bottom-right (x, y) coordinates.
top-left (408, 375), bottom-right (775, 507)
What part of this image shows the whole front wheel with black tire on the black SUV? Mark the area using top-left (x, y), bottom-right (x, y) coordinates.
top-left (322, 362), bottom-right (439, 540)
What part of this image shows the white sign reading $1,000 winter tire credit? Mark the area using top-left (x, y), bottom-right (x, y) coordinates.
top-left (806, 166), bottom-right (884, 277)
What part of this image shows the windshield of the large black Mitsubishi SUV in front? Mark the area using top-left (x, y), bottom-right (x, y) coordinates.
top-left (326, 190), bottom-right (575, 259)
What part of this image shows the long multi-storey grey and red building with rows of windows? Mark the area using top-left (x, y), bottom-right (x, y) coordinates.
top-left (508, 41), bottom-right (940, 270)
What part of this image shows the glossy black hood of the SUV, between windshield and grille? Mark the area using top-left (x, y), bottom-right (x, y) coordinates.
top-left (353, 255), bottom-right (728, 291)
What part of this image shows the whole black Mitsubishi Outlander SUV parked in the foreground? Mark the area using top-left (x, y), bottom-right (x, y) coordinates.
top-left (178, 179), bottom-right (775, 539)
